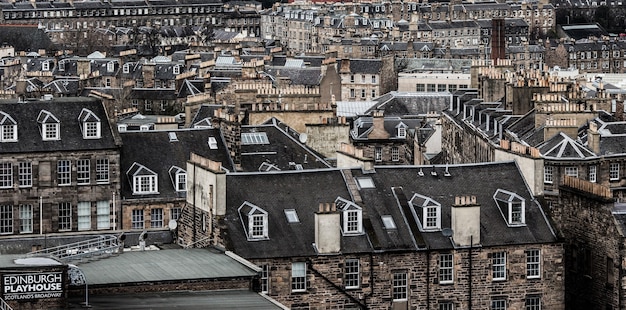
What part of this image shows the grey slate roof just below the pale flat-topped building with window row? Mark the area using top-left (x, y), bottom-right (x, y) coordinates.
top-left (365, 91), bottom-right (452, 116)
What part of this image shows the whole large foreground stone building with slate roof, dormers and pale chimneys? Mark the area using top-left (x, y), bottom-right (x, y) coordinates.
top-left (181, 157), bottom-right (564, 309)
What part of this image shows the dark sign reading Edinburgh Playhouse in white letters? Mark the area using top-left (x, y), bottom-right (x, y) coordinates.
top-left (2, 272), bottom-right (63, 300)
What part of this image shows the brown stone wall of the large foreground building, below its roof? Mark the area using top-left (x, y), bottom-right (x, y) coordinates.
top-left (244, 243), bottom-right (569, 309)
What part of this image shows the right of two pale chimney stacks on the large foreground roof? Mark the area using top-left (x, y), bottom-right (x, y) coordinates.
top-left (452, 196), bottom-right (480, 246)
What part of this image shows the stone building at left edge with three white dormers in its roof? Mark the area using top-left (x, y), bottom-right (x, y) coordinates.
top-left (0, 98), bottom-right (121, 237)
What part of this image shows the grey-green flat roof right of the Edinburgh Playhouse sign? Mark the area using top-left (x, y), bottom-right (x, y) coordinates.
top-left (78, 249), bottom-right (258, 285)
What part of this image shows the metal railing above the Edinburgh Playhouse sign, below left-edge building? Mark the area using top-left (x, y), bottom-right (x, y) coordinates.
top-left (26, 235), bottom-right (120, 262)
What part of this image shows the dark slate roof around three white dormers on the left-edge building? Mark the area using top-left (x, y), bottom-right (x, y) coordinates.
top-left (0, 97), bottom-right (117, 154)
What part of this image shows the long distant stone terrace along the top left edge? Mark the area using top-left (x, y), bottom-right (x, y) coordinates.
top-left (0, 0), bottom-right (261, 55)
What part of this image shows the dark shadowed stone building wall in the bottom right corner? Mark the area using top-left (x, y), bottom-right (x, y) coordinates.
top-left (550, 177), bottom-right (626, 309)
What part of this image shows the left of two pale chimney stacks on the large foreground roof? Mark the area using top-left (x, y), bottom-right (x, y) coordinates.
top-left (315, 203), bottom-right (341, 254)
